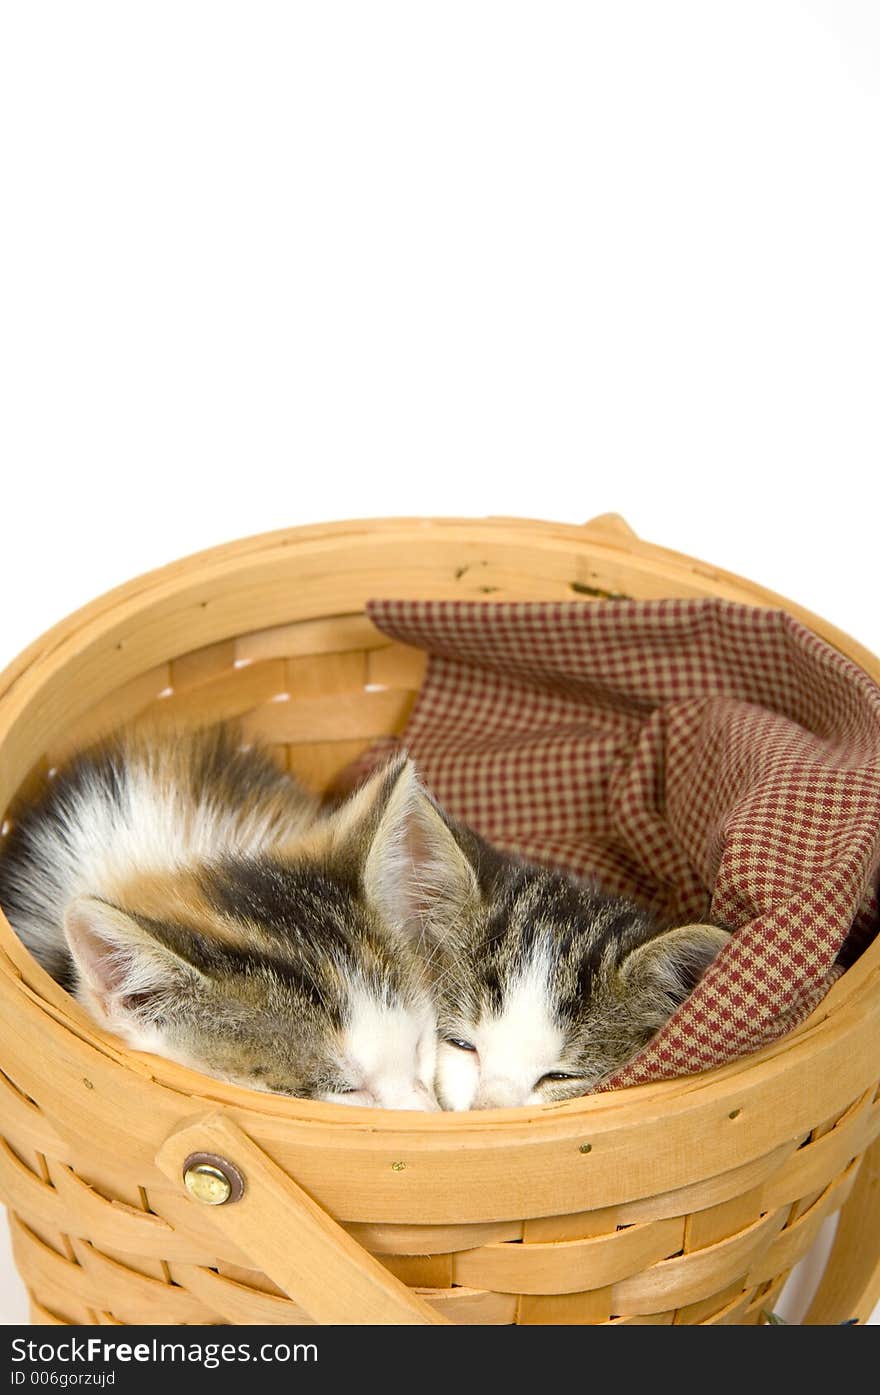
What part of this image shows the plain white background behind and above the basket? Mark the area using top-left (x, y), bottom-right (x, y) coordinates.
top-left (0, 0), bottom-right (880, 1322)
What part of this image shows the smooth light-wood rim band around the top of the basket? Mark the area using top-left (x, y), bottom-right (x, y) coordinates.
top-left (0, 516), bottom-right (880, 1143)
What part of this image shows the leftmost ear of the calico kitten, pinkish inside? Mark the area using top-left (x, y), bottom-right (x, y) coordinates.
top-left (64, 896), bottom-right (203, 1017)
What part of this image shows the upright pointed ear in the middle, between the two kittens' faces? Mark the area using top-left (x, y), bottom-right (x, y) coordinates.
top-left (351, 759), bottom-right (478, 939)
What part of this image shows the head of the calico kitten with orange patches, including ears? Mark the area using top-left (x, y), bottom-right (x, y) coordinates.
top-left (64, 760), bottom-right (437, 1109)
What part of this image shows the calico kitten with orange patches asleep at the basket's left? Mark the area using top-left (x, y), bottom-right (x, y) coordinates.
top-left (0, 727), bottom-right (437, 1109)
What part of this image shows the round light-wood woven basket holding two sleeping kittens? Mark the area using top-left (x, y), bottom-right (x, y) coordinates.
top-left (0, 516), bottom-right (880, 1324)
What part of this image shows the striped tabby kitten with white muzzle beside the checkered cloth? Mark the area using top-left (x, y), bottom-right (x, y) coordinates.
top-left (362, 764), bottom-right (729, 1109)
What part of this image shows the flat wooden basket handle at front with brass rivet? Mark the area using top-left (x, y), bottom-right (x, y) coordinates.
top-left (156, 1113), bottom-right (449, 1327)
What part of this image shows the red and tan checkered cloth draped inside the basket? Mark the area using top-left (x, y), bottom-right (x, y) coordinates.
top-left (357, 600), bottom-right (880, 1088)
